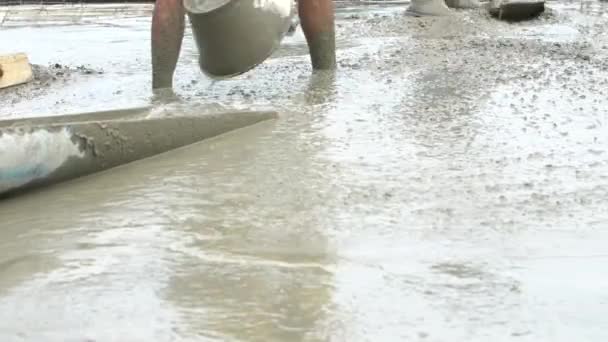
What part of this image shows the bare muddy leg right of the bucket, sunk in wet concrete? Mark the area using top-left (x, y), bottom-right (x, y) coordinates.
top-left (298, 0), bottom-right (336, 70)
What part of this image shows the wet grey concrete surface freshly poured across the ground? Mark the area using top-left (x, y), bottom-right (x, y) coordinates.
top-left (0, 1), bottom-right (608, 342)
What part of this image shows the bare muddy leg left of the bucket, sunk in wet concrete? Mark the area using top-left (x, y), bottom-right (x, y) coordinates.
top-left (152, 0), bottom-right (185, 89)
